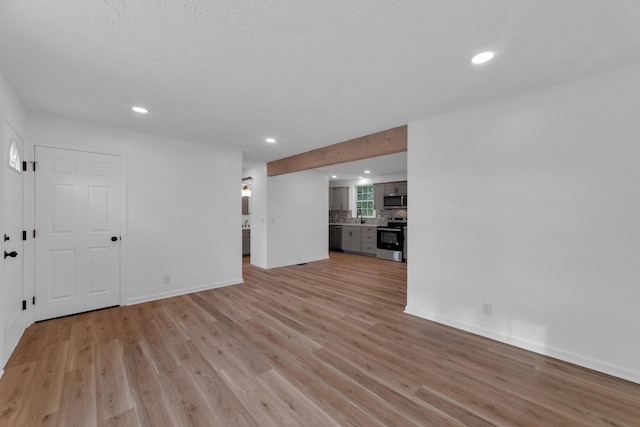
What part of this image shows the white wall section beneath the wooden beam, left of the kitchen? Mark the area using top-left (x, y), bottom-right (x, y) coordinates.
top-left (264, 171), bottom-right (329, 268)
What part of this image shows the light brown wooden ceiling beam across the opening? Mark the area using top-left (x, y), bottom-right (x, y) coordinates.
top-left (267, 125), bottom-right (407, 176)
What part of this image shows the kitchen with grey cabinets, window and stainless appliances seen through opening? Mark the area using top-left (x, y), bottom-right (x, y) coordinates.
top-left (329, 179), bottom-right (408, 262)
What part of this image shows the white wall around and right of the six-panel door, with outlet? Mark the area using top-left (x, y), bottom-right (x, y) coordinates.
top-left (28, 115), bottom-right (242, 304)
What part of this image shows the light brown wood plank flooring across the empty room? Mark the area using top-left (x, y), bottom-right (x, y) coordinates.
top-left (0, 253), bottom-right (640, 427)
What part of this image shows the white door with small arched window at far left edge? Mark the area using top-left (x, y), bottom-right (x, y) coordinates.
top-left (0, 122), bottom-right (24, 367)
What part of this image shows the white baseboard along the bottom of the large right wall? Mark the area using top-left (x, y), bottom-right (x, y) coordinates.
top-left (404, 305), bottom-right (640, 384)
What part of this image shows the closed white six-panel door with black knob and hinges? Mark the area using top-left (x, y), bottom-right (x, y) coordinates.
top-left (34, 146), bottom-right (120, 320)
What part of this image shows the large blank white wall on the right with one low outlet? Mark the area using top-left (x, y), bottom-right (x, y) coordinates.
top-left (406, 64), bottom-right (640, 382)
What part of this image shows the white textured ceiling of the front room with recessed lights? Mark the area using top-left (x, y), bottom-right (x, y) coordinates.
top-left (0, 0), bottom-right (640, 166)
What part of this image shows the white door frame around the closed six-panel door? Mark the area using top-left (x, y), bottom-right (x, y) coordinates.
top-left (25, 139), bottom-right (128, 326)
